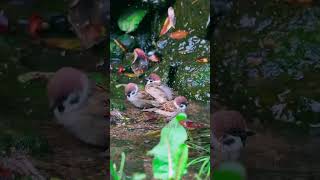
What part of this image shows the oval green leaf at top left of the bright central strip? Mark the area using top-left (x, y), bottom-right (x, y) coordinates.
top-left (118, 8), bottom-right (147, 33)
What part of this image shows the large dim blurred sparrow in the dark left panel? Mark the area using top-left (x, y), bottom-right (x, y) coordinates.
top-left (47, 67), bottom-right (109, 146)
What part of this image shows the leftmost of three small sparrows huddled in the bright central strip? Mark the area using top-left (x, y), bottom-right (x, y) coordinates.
top-left (124, 83), bottom-right (160, 108)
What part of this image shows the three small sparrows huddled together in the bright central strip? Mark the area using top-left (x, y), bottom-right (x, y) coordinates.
top-left (125, 73), bottom-right (188, 120)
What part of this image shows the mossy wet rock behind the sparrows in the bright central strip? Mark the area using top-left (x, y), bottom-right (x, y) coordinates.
top-left (152, 0), bottom-right (210, 102)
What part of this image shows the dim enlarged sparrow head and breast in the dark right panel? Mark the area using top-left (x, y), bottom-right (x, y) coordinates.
top-left (211, 110), bottom-right (253, 167)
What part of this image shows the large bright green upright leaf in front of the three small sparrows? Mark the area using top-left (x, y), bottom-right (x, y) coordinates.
top-left (148, 113), bottom-right (188, 180)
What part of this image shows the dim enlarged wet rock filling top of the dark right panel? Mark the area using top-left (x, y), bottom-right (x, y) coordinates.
top-left (214, 1), bottom-right (320, 124)
